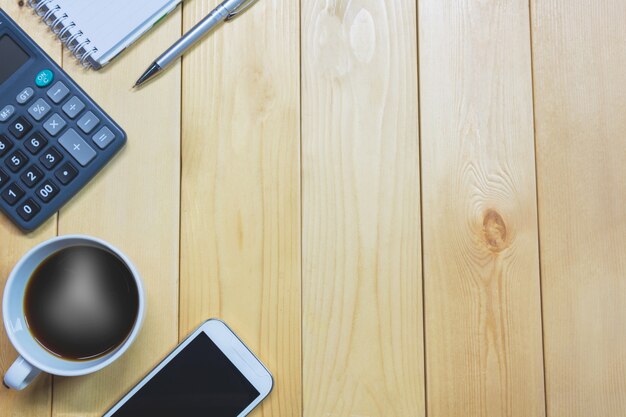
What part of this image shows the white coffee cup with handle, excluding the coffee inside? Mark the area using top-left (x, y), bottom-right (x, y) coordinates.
top-left (2, 235), bottom-right (145, 390)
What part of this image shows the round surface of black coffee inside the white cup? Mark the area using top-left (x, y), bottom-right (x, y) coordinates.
top-left (24, 246), bottom-right (139, 361)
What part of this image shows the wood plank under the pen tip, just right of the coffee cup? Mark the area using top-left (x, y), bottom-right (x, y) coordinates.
top-left (53, 6), bottom-right (182, 417)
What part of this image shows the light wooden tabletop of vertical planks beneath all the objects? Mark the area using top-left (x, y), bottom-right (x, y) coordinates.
top-left (0, 0), bottom-right (626, 417)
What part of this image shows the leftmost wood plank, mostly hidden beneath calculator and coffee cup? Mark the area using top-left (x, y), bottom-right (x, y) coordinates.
top-left (0, 0), bottom-right (61, 417)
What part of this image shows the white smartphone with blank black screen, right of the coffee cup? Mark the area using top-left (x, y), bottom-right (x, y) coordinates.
top-left (103, 319), bottom-right (274, 417)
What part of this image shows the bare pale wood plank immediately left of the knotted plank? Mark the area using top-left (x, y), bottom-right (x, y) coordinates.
top-left (302, 0), bottom-right (425, 417)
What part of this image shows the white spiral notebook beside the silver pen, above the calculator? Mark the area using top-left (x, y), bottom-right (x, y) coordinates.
top-left (28, 0), bottom-right (182, 69)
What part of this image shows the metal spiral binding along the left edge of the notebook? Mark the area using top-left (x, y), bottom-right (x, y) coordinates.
top-left (27, 0), bottom-right (98, 67)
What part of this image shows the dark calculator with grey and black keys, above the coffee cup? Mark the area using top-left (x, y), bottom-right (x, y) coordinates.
top-left (0, 9), bottom-right (126, 231)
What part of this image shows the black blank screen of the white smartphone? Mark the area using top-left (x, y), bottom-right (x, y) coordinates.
top-left (108, 332), bottom-right (261, 417)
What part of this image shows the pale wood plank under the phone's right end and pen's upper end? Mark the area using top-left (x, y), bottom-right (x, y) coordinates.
top-left (180, 0), bottom-right (302, 416)
